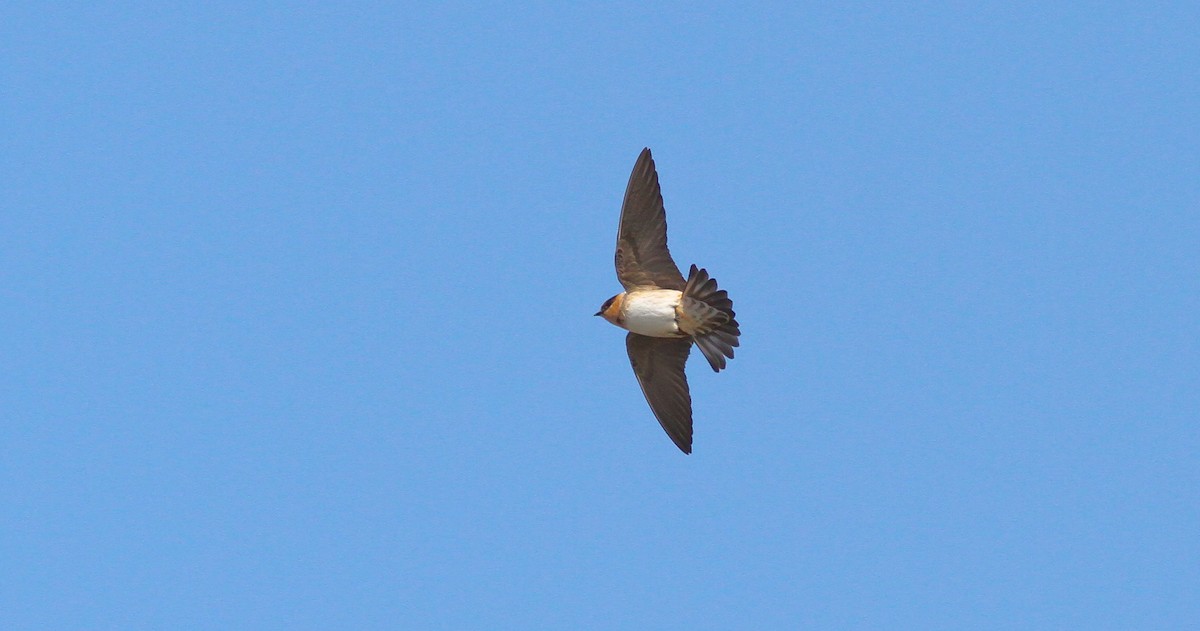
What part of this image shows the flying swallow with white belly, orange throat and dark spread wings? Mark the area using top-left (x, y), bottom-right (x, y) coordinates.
top-left (595, 148), bottom-right (742, 453)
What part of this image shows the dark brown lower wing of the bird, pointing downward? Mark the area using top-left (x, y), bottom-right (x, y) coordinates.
top-left (625, 333), bottom-right (691, 453)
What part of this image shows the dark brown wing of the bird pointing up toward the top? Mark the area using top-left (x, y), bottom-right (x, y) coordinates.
top-left (617, 149), bottom-right (684, 292)
